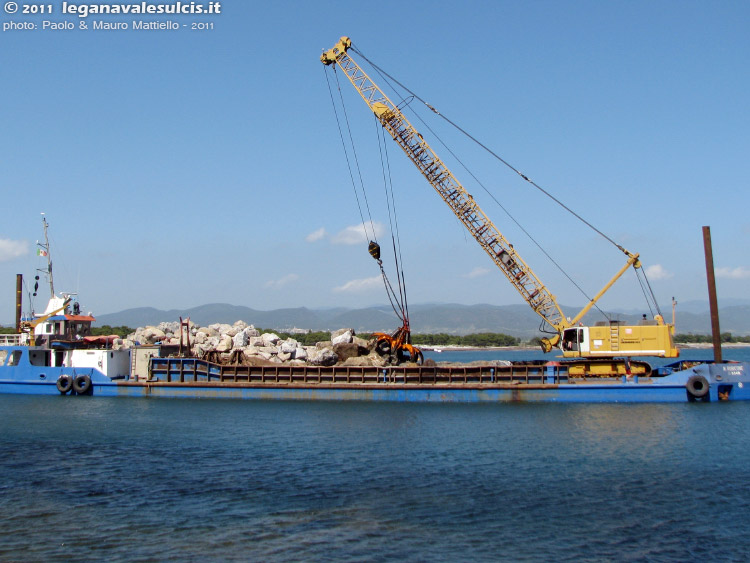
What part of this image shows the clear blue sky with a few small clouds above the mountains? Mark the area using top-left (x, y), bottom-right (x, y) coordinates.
top-left (0, 0), bottom-right (750, 324)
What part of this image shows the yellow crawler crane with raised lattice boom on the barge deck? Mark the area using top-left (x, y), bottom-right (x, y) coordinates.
top-left (320, 37), bottom-right (679, 376)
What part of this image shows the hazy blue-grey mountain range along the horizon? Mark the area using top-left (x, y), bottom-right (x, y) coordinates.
top-left (96, 301), bottom-right (750, 339)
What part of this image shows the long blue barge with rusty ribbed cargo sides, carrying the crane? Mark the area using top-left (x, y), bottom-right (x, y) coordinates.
top-left (0, 342), bottom-right (750, 403)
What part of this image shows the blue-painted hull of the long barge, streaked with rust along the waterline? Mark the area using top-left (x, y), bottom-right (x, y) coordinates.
top-left (0, 348), bottom-right (750, 403)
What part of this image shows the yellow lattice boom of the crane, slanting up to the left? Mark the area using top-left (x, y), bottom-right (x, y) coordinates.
top-left (321, 37), bottom-right (568, 332)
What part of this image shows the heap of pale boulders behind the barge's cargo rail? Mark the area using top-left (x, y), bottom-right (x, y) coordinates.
top-left (115, 321), bottom-right (400, 367)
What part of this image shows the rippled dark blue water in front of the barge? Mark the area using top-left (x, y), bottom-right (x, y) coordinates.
top-left (0, 348), bottom-right (750, 561)
